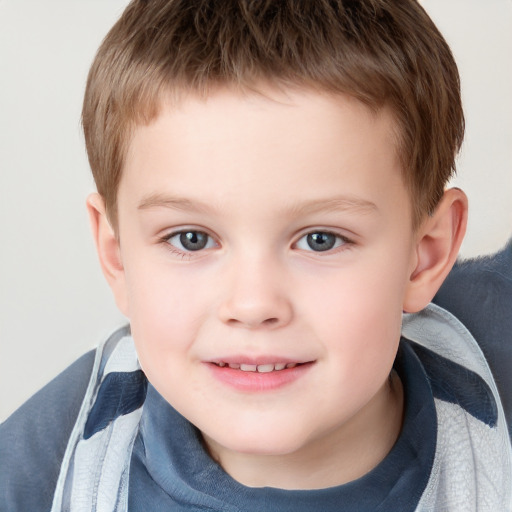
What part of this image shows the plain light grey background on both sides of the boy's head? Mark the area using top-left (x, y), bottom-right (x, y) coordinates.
top-left (0, 0), bottom-right (512, 420)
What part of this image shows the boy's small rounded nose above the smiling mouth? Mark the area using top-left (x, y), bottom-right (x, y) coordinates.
top-left (219, 254), bottom-right (293, 329)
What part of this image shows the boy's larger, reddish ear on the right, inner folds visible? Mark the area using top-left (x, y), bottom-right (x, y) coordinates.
top-left (403, 188), bottom-right (468, 313)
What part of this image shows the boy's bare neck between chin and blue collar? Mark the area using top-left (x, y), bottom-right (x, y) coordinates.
top-left (205, 371), bottom-right (403, 489)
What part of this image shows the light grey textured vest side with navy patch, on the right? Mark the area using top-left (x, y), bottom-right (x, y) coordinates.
top-left (403, 305), bottom-right (512, 510)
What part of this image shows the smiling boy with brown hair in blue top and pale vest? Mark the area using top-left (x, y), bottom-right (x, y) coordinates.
top-left (0, 0), bottom-right (512, 512)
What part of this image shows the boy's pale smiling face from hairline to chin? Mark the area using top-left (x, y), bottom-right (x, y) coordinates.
top-left (117, 85), bottom-right (416, 472)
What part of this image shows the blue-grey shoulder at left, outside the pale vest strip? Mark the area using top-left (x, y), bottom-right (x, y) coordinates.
top-left (0, 351), bottom-right (95, 511)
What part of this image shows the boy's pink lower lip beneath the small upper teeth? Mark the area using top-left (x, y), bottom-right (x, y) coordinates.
top-left (208, 363), bottom-right (314, 393)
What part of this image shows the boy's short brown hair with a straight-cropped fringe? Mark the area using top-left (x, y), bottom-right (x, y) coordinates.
top-left (82, 0), bottom-right (464, 226)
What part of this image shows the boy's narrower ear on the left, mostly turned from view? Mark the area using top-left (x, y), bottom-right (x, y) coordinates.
top-left (86, 193), bottom-right (128, 317)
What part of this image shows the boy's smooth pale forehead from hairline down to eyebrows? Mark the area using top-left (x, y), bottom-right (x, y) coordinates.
top-left (119, 84), bottom-right (401, 220)
